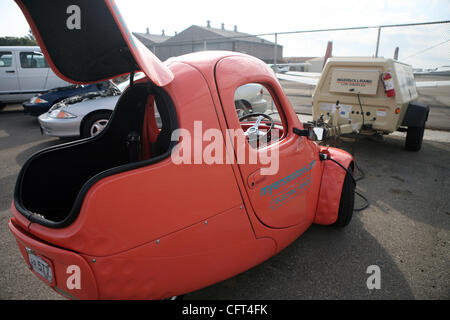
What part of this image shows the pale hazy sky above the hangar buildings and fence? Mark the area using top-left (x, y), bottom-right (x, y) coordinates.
top-left (0, 0), bottom-right (450, 68)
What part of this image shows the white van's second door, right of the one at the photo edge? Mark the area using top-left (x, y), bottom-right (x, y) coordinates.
top-left (18, 50), bottom-right (49, 94)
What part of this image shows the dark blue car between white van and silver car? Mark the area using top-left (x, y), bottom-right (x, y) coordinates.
top-left (23, 81), bottom-right (109, 116)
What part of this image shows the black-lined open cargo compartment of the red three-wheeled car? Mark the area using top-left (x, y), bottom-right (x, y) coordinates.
top-left (15, 83), bottom-right (177, 227)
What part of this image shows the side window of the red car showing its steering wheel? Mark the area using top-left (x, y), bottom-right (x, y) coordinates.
top-left (234, 83), bottom-right (287, 148)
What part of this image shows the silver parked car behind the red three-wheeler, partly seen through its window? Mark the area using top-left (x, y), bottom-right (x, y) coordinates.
top-left (39, 80), bottom-right (267, 138)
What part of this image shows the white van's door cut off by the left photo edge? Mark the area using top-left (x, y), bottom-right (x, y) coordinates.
top-left (0, 50), bottom-right (19, 97)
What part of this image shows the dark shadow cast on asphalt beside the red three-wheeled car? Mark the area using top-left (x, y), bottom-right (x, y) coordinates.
top-left (185, 216), bottom-right (413, 300)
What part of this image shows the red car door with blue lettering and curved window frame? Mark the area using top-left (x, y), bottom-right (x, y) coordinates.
top-left (215, 56), bottom-right (321, 228)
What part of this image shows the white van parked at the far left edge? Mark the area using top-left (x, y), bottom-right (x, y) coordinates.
top-left (0, 46), bottom-right (70, 109)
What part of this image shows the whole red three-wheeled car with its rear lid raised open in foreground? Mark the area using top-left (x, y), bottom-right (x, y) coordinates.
top-left (9, 0), bottom-right (355, 299)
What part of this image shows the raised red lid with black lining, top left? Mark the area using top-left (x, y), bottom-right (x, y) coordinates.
top-left (15, 0), bottom-right (173, 87)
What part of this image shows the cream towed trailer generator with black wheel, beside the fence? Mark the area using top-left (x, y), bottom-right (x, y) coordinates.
top-left (313, 57), bottom-right (430, 151)
